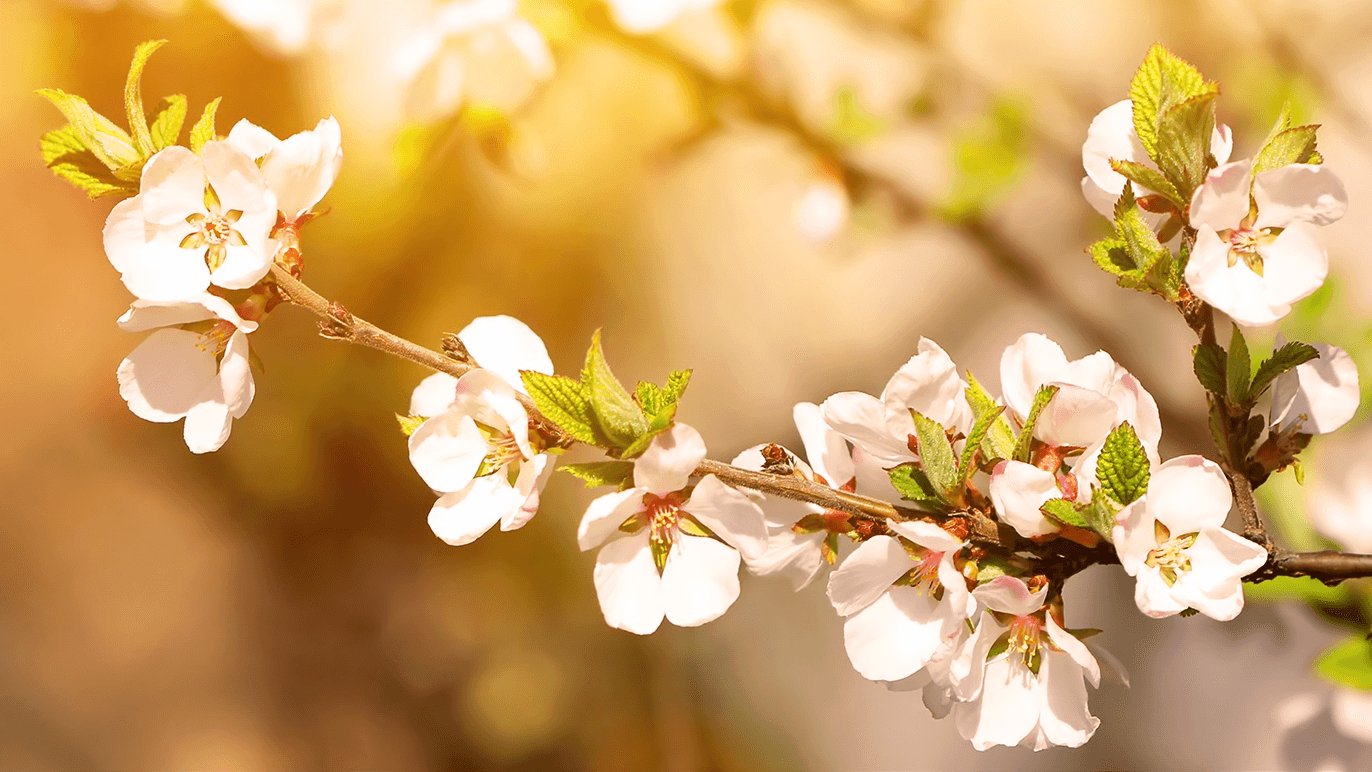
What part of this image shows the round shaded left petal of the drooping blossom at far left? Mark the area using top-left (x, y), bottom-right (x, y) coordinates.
top-left (118, 329), bottom-right (218, 424)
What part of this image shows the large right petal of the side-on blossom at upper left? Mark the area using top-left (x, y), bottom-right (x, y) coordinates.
top-left (259, 118), bottom-right (343, 219)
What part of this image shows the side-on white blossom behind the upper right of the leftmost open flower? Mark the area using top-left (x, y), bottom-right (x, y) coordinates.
top-left (228, 117), bottom-right (343, 222)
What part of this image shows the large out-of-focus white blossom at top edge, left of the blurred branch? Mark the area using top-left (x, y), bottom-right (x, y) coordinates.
top-left (392, 0), bottom-right (553, 123)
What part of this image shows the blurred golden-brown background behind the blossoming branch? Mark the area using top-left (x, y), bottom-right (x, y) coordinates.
top-left (0, 0), bottom-right (1372, 772)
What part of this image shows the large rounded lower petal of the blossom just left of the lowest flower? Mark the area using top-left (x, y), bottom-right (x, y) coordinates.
top-left (844, 587), bottom-right (945, 681)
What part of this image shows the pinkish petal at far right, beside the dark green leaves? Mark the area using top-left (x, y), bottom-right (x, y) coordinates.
top-left (1272, 341), bottom-right (1361, 435)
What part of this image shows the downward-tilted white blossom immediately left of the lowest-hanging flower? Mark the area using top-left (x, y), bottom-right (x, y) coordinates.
top-left (829, 520), bottom-right (975, 681)
